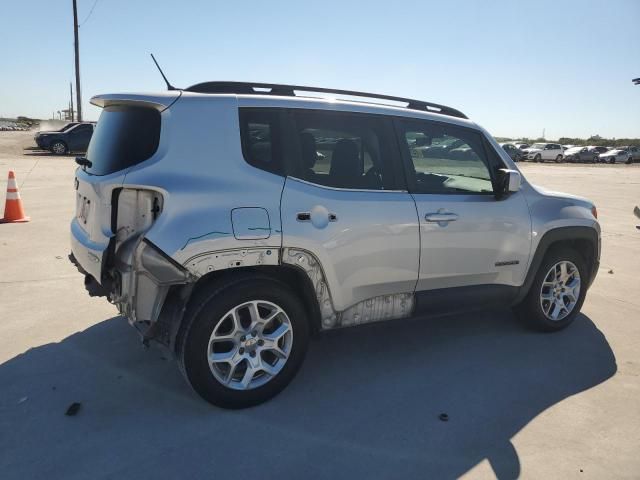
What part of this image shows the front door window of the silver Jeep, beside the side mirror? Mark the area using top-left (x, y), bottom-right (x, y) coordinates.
top-left (400, 122), bottom-right (493, 194)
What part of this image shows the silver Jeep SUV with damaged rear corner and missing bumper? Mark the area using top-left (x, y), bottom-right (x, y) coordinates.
top-left (71, 82), bottom-right (600, 408)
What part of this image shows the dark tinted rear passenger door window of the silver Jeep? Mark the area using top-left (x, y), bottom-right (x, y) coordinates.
top-left (294, 111), bottom-right (394, 190)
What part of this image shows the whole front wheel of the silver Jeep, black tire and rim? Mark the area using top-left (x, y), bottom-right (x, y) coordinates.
top-left (516, 248), bottom-right (588, 332)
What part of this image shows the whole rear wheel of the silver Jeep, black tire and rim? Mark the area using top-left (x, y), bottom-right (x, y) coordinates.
top-left (177, 274), bottom-right (309, 409)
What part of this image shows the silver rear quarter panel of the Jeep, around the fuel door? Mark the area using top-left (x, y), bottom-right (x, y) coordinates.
top-left (124, 93), bottom-right (284, 274)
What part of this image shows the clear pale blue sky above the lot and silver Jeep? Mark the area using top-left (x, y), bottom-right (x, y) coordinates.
top-left (0, 0), bottom-right (640, 139)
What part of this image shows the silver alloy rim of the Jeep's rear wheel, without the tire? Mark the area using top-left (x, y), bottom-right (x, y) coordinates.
top-left (207, 300), bottom-right (293, 390)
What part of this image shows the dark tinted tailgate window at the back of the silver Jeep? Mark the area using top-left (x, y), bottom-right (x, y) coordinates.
top-left (87, 106), bottom-right (160, 175)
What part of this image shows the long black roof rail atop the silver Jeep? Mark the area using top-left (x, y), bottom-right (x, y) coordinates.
top-left (185, 82), bottom-right (467, 118)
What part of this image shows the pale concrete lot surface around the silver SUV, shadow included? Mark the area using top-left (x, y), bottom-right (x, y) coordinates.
top-left (0, 132), bottom-right (640, 479)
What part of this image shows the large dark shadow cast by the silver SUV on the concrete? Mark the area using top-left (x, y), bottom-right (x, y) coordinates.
top-left (0, 311), bottom-right (616, 479)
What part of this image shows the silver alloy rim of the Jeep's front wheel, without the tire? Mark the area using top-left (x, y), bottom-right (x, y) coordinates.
top-left (540, 260), bottom-right (580, 322)
